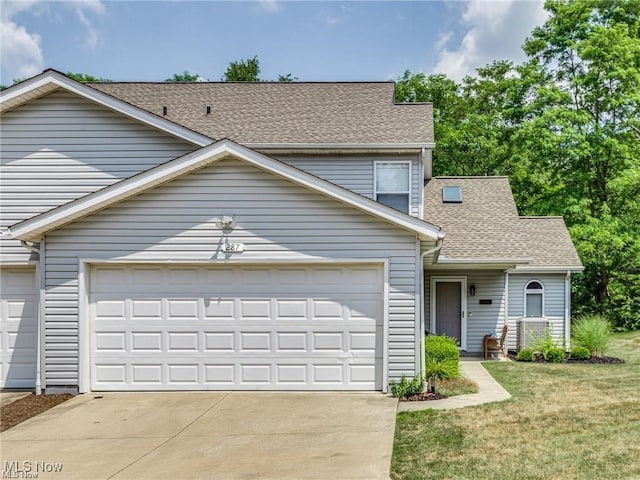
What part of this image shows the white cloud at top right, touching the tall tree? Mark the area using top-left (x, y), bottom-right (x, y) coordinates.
top-left (433, 0), bottom-right (547, 81)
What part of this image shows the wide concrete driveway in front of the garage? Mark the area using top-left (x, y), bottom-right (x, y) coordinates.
top-left (1, 392), bottom-right (396, 480)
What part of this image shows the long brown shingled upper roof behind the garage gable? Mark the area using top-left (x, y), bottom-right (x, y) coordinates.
top-left (88, 82), bottom-right (434, 146)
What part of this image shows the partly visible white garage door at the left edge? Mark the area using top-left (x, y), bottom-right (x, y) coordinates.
top-left (0, 268), bottom-right (38, 388)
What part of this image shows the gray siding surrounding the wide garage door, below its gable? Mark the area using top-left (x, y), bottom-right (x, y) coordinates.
top-left (45, 159), bottom-right (417, 386)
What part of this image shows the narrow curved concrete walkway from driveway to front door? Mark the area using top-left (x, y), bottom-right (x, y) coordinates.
top-left (398, 358), bottom-right (511, 412)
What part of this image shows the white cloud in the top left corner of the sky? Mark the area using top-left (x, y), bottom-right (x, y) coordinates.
top-left (0, 1), bottom-right (44, 85)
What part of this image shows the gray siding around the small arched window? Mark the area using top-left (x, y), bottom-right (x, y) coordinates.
top-left (509, 274), bottom-right (565, 349)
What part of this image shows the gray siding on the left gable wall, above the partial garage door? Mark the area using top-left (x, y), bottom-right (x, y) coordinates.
top-left (0, 90), bottom-right (195, 262)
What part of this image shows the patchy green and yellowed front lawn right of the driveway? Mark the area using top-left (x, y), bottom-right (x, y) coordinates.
top-left (391, 332), bottom-right (640, 480)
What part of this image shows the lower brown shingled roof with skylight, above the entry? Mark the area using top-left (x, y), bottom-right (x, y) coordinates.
top-left (424, 177), bottom-right (582, 267)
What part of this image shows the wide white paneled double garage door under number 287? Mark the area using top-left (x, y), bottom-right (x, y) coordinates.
top-left (90, 265), bottom-right (383, 390)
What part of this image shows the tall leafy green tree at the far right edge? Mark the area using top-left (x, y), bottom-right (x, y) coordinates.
top-left (521, 0), bottom-right (640, 328)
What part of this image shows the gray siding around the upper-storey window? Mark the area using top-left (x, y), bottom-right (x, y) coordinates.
top-left (278, 155), bottom-right (423, 217)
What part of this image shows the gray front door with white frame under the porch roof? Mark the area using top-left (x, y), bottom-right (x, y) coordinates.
top-left (432, 278), bottom-right (466, 349)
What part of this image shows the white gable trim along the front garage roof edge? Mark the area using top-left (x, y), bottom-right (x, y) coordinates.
top-left (11, 140), bottom-right (444, 240)
